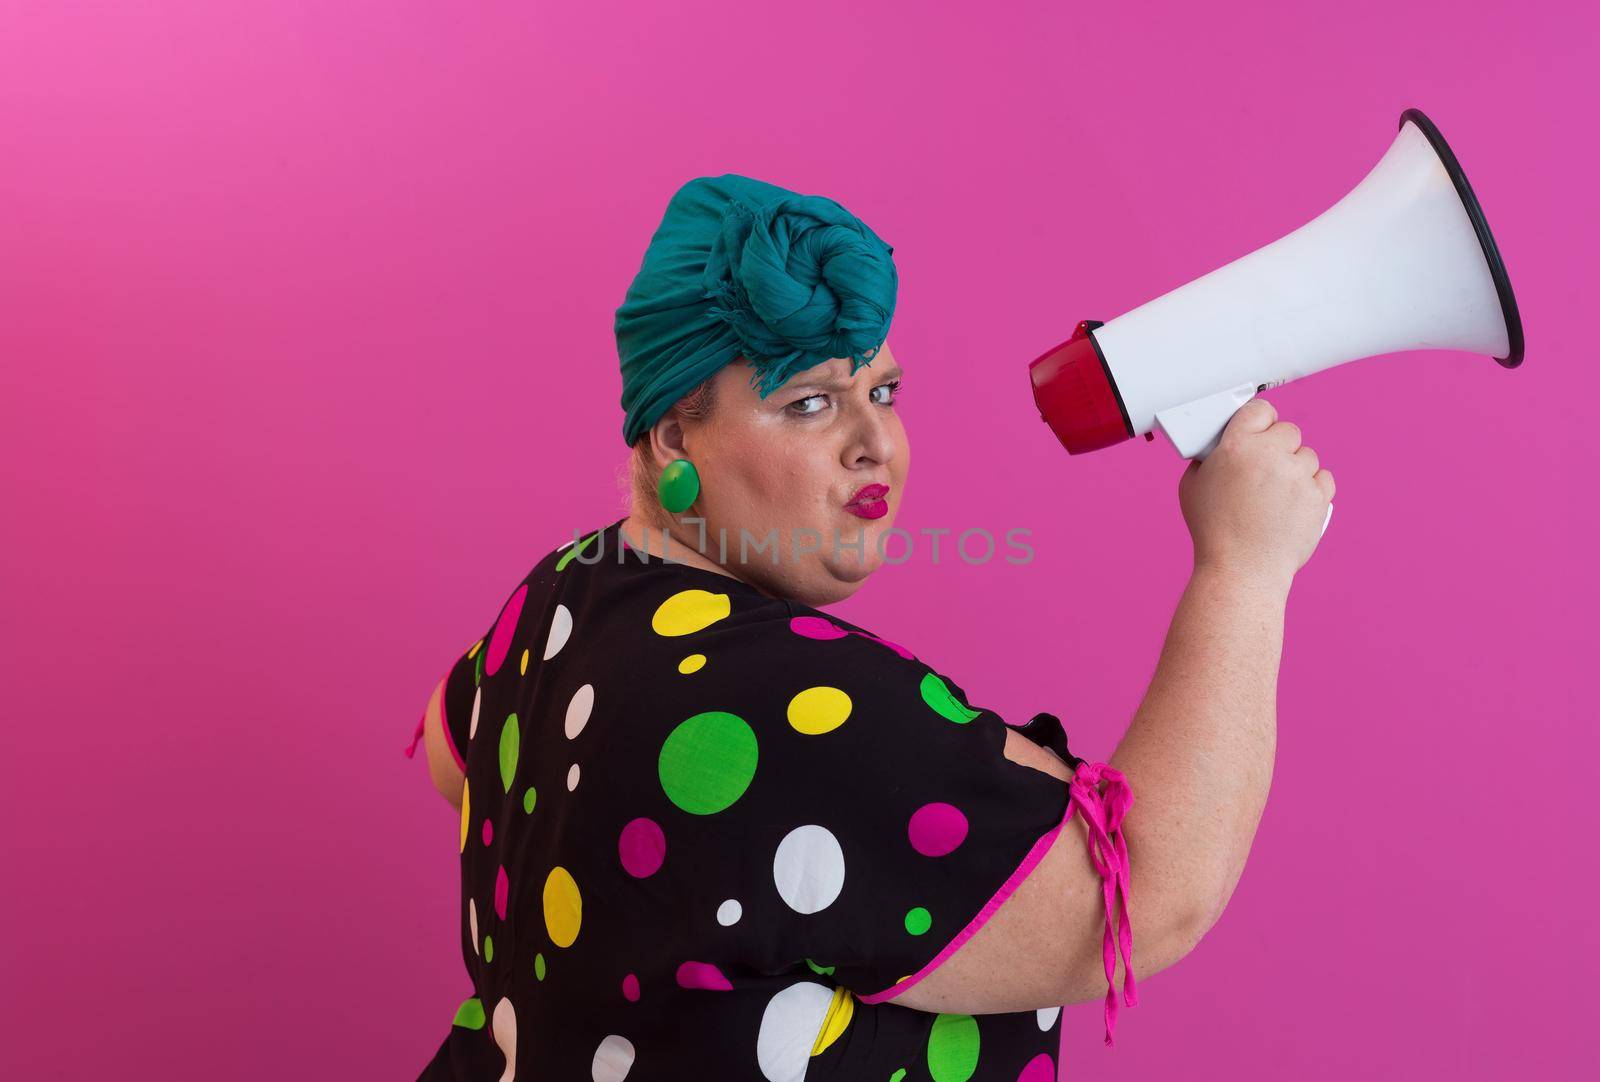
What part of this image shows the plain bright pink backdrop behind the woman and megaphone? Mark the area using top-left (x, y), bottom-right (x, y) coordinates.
top-left (0, 0), bottom-right (1600, 1082)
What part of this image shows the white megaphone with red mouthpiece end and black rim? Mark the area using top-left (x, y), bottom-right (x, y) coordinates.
top-left (1029, 109), bottom-right (1523, 530)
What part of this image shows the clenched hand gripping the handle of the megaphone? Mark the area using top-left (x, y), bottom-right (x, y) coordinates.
top-left (1178, 399), bottom-right (1334, 581)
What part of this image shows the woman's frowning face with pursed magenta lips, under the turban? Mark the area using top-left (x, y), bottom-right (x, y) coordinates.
top-left (674, 343), bottom-right (910, 607)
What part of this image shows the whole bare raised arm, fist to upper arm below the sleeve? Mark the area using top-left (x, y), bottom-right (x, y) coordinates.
top-left (896, 399), bottom-right (1334, 1013)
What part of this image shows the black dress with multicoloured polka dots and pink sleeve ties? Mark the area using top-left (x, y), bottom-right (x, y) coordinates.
top-left (413, 520), bottom-right (1136, 1082)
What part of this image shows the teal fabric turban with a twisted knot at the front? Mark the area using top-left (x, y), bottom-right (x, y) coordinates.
top-left (616, 173), bottom-right (899, 443)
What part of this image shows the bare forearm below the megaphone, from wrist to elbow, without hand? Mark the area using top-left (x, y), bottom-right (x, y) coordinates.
top-left (1110, 567), bottom-right (1291, 938)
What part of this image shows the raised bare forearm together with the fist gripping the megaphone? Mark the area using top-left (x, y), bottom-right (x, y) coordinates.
top-left (1112, 399), bottom-right (1334, 941)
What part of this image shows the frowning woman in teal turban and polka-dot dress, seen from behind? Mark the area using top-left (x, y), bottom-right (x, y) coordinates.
top-left (408, 174), bottom-right (1333, 1082)
